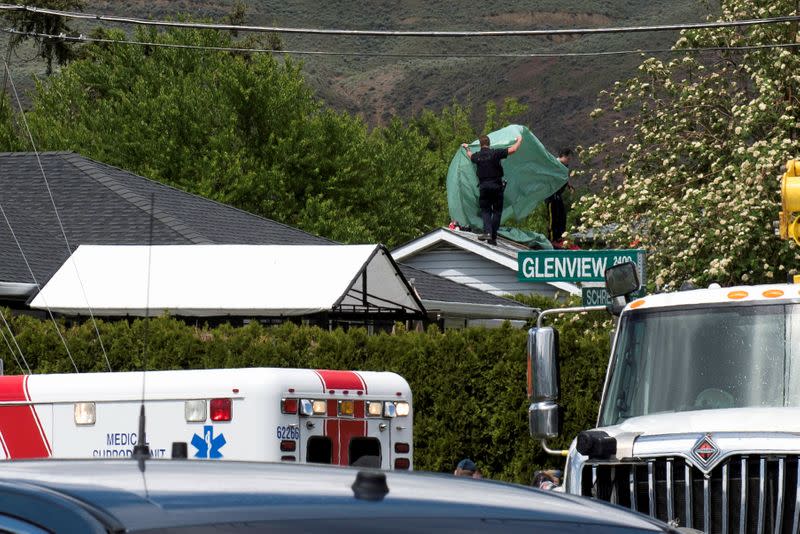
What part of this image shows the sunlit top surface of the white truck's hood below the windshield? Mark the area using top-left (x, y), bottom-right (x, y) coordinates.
top-left (603, 408), bottom-right (800, 435)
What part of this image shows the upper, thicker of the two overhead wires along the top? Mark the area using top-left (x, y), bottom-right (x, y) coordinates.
top-left (0, 4), bottom-right (800, 37)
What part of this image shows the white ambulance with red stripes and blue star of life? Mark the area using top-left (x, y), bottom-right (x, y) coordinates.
top-left (0, 368), bottom-right (413, 469)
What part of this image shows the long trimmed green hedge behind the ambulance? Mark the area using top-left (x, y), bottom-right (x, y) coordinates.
top-left (2, 306), bottom-right (609, 483)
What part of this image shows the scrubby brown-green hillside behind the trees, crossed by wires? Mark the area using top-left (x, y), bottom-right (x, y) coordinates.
top-left (4, 0), bottom-right (713, 155)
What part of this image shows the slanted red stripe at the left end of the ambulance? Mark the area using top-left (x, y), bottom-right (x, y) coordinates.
top-left (0, 375), bottom-right (51, 459)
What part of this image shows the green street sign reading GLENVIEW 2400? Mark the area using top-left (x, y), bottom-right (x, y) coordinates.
top-left (517, 249), bottom-right (645, 284)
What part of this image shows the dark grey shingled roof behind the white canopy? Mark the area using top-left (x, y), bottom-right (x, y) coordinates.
top-left (0, 152), bottom-right (334, 285)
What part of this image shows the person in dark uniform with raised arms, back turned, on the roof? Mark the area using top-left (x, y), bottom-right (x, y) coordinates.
top-left (461, 135), bottom-right (522, 245)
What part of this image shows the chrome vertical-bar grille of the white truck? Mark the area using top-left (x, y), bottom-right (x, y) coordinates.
top-left (581, 455), bottom-right (800, 534)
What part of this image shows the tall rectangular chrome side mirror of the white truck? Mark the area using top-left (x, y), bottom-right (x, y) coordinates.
top-left (528, 326), bottom-right (561, 439)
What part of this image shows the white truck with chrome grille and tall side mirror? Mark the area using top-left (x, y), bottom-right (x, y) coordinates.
top-left (528, 264), bottom-right (800, 534)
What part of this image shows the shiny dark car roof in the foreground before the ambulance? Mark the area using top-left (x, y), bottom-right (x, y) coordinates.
top-left (0, 460), bottom-right (676, 532)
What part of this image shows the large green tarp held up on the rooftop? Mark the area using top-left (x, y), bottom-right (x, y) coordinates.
top-left (447, 124), bottom-right (569, 248)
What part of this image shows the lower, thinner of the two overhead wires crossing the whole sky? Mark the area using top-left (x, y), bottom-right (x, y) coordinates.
top-left (0, 28), bottom-right (800, 59)
